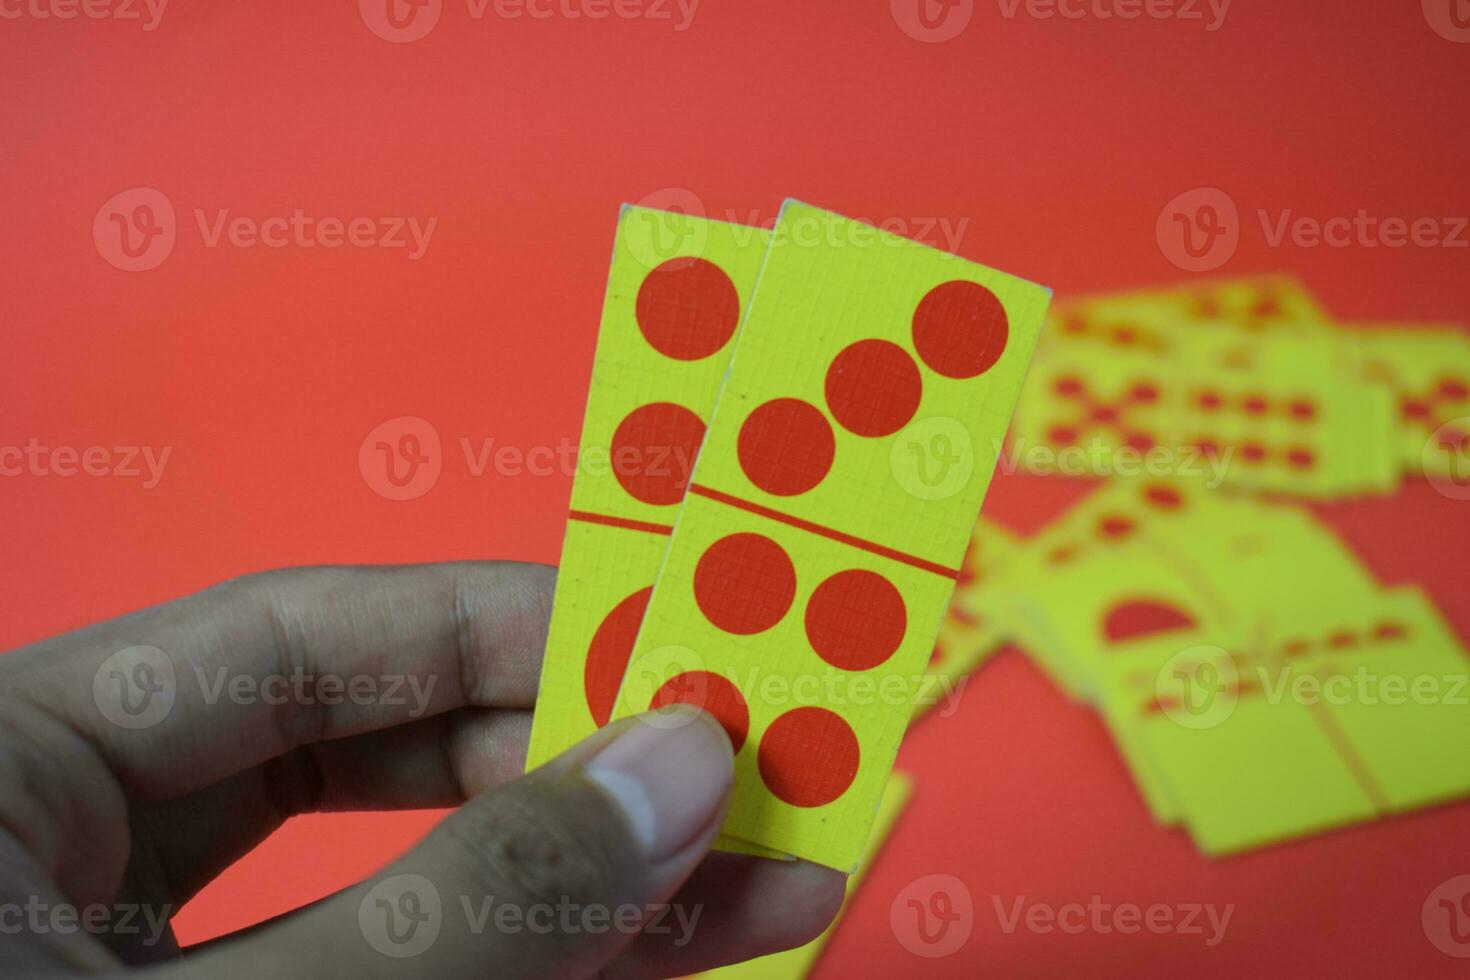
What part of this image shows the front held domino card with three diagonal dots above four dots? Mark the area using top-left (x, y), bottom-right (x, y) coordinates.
top-left (617, 201), bottom-right (1050, 870)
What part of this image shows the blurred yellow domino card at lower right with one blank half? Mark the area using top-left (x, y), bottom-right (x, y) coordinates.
top-left (1105, 589), bottom-right (1470, 857)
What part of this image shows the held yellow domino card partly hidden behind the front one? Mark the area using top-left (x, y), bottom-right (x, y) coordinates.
top-left (528, 207), bottom-right (769, 768)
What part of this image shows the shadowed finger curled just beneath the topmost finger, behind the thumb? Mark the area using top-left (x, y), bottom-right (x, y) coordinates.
top-left (129, 708), bottom-right (531, 907)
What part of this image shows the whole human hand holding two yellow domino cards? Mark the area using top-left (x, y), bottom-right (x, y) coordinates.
top-left (0, 563), bottom-right (844, 980)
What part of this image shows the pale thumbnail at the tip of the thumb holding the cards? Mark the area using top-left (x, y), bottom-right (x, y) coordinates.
top-left (587, 705), bottom-right (732, 861)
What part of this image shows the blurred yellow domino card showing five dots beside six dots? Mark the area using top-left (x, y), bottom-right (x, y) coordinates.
top-left (1011, 325), bottom-right (1398, 500)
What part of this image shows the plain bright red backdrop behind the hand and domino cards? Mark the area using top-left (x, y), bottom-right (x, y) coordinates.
top-left (0, 0), bottom-right (1470, 977)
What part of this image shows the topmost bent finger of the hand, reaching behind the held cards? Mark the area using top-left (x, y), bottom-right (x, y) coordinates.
top-left (0, 563), bottom-right (554, 799)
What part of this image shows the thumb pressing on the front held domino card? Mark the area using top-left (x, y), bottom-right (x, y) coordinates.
top-left (191, 707), bottom-right (732, 980)
